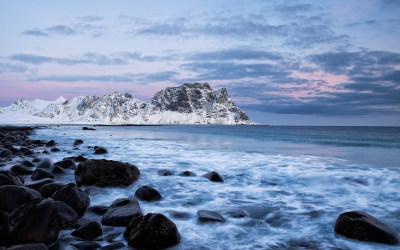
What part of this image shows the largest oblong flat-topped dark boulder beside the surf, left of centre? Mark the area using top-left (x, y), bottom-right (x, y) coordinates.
top-left (75, 160), bottom-right (140, 187)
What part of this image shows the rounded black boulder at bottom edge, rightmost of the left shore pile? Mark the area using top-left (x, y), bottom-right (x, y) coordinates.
top-left (124, 213), bottom-right (181, 249)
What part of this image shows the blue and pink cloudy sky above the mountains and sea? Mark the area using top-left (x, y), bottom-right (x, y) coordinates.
top-left (0, 0), bottom-right (400, 126)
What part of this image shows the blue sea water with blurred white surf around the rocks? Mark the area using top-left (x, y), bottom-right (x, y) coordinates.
top-left (28, 126), bottom-right (400, 249)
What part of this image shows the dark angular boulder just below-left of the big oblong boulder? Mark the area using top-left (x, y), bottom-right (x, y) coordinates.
top-left (53, 183), bottom-right (90, 216)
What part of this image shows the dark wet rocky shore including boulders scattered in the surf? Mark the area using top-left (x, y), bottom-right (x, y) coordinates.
top-left (0, 127), bottom-right (399, 249)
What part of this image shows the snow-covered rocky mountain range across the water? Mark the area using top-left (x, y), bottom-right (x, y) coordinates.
top-left (0, 83), bottom-right (254, 125)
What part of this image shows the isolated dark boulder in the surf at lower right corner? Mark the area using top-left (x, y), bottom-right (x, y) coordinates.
top-left (335, 211), bottom-right (399, 245)
